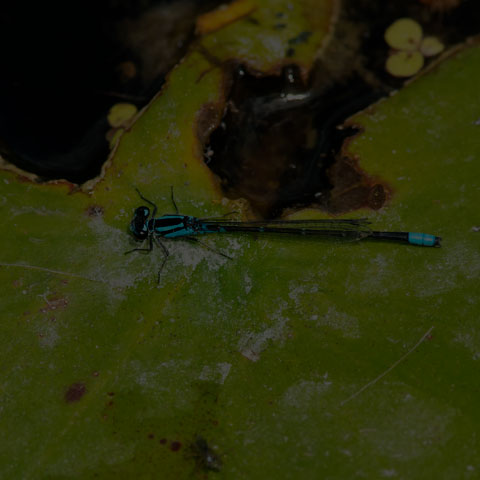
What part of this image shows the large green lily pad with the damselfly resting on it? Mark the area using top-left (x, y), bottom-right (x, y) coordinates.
top-left (0, 2), bottom-right (480, 479)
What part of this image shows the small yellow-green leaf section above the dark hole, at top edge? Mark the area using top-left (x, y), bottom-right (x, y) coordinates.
top-left (197, 0), bottom-right (339, 78)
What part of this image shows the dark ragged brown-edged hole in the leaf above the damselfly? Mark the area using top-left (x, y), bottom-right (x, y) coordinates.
top-left (203, 66), bottom-right (385, 217)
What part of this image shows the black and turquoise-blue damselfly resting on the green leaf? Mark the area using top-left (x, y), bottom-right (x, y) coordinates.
top-left (125, 188), bottom-right (441, 282)
